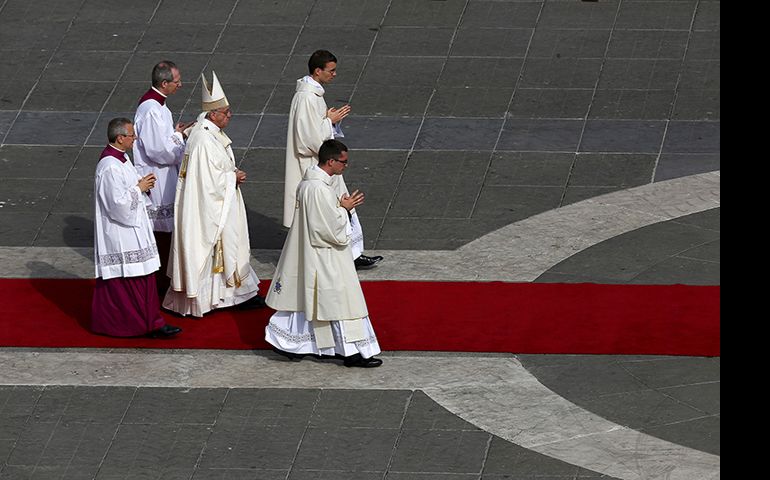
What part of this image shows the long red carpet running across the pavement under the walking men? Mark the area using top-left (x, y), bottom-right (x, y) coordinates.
top-left (0, 279), bottom-right (720, 356)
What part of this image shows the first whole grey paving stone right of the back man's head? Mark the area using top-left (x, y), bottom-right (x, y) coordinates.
top-left (360, 55), bottom-right (445, 87)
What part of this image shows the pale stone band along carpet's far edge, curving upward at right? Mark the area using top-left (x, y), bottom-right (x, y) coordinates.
top-left (0, 171), bottom-right (720, 282)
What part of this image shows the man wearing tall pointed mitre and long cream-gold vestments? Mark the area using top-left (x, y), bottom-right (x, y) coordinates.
top-left (163, 73), bottom-right (264, 317)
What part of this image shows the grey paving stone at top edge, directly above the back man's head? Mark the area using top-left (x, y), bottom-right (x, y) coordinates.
top-left (307, 0), bottom-right (391, 28)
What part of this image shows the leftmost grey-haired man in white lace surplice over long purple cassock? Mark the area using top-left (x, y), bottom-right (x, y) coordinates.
top-left (91, 118), bottom-right (182, 338)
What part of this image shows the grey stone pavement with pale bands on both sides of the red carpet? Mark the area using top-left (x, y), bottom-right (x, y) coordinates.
top-left (0, 0), bottom-right (720, 480)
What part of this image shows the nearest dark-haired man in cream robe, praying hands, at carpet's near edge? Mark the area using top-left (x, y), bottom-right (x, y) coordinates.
top-left (265, 140), bottom-right (382, 368)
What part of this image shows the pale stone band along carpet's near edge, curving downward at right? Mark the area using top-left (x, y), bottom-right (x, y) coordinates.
top-left (0, 351), bottom-right (720, 480)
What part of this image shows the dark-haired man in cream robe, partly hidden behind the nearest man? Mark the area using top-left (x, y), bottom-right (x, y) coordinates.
top-left (283, 50), bottom-right (382, 269)
